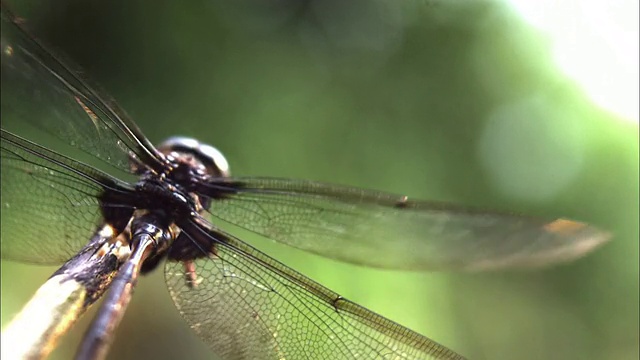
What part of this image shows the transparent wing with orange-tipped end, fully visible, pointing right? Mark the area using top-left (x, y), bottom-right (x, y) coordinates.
top-left (201, 178), bottom-right (609, 270)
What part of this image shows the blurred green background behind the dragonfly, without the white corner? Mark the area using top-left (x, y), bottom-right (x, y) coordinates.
top-left (1, 0), bottom-right (639, 359)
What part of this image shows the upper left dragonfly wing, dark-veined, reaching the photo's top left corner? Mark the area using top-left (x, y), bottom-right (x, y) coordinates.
top-left (1, 4), bottom-right (160, 172)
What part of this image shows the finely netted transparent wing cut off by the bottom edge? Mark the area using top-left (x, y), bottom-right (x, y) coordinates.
top-left (165, 219), bottom-right (463, 360)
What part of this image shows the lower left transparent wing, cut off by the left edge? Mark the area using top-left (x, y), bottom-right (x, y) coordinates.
top-left (0, 129), bottom-right (134, 264)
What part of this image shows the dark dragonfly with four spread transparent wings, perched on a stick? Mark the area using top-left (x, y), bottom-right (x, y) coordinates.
top-left (0, 5), bottom-right (610, 359)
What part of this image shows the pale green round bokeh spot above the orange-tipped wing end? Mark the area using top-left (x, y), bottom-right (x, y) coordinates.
top-left (478, 96), bottom-right (585, 202)
